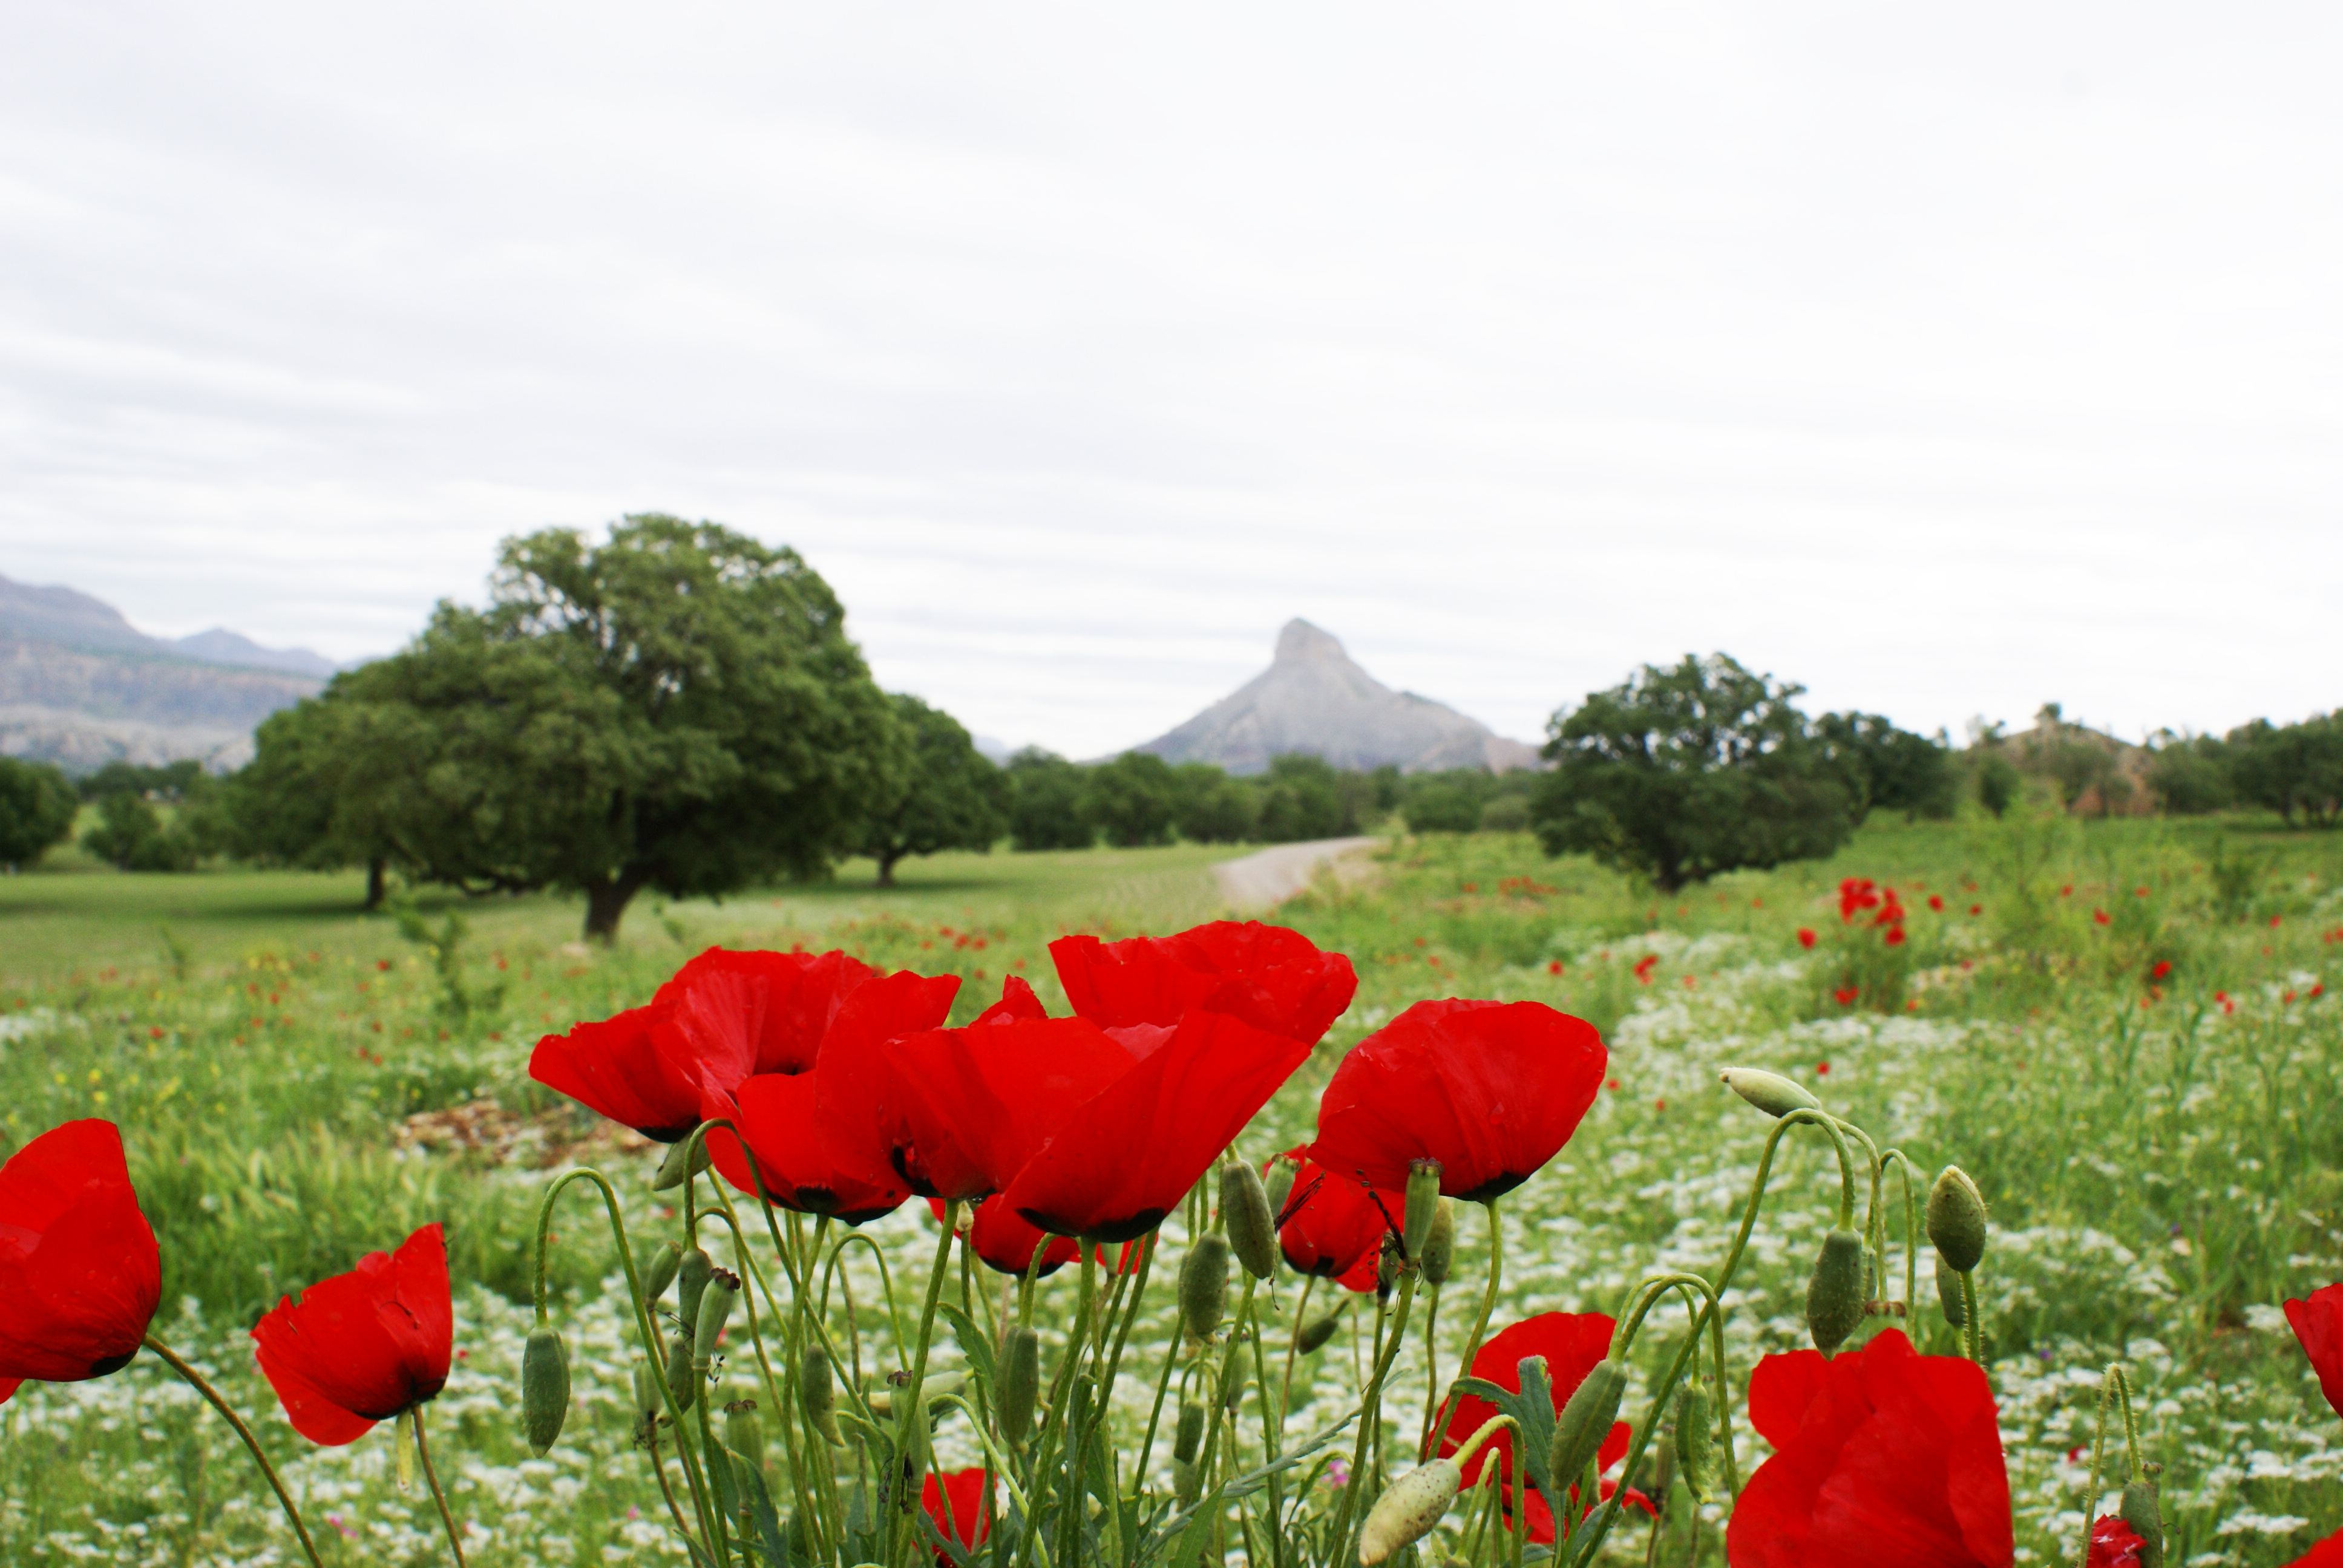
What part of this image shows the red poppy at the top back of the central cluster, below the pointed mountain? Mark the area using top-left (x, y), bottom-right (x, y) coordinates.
top-left (1050, 921), bottom-right (1359, 1045)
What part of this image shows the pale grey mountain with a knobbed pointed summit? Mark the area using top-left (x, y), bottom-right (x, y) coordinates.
top-left (1132, 619), bottom-right (1537, 774)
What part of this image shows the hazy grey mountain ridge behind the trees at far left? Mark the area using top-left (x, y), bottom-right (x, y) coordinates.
top-left (0, 577), bottom-right (338, 774)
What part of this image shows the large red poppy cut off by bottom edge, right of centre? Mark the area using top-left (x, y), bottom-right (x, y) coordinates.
top-left (1725, 1329), bottom-right (2015, 1568)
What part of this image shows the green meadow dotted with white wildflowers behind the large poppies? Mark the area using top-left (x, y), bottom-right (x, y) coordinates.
top-left (0, 811), bottom-right (2343, 1566)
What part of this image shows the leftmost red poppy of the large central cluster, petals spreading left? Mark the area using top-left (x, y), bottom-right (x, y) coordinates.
top-left (529, 947), bottom-right (874, 1144)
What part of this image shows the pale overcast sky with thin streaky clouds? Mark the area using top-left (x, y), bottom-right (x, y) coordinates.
top-left (0, 0), bottom-right (2343, 755)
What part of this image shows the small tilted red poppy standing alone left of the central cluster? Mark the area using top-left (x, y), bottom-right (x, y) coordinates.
top-left (253, 1223), bottom-right (454, 1446)
